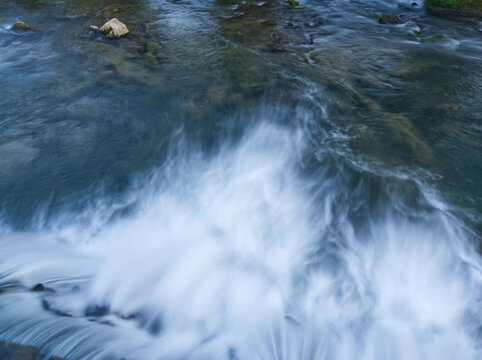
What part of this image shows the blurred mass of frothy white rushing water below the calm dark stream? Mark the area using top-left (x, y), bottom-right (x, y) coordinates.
top-left (0, 124), bottom-right (482, 360)
